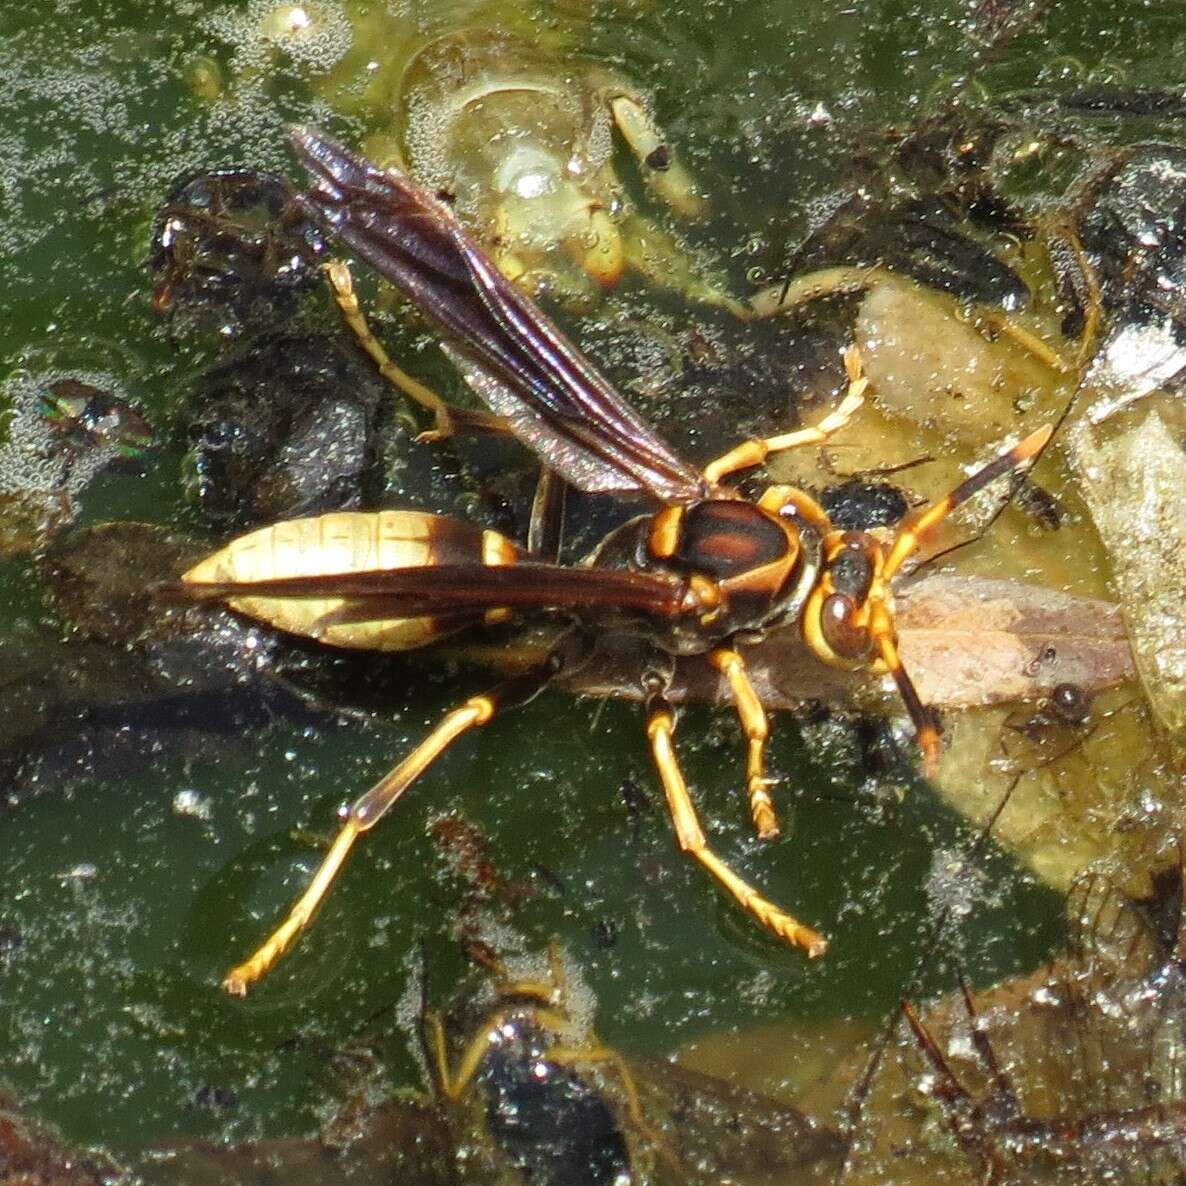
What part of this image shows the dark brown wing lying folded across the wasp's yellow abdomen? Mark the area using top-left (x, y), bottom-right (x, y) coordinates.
top-left (167, 565), bottom-right (682, 623)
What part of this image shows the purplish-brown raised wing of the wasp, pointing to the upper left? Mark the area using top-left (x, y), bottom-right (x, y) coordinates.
top-left (293, 129), bottom-right (707, 503)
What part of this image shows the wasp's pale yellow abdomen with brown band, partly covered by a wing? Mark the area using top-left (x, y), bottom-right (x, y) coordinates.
top-left (181, 511), bottom-right (519, 651)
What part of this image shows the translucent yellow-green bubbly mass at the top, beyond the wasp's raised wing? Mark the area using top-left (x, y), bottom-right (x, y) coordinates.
top-left (196, 0), bottom-right (740, 308)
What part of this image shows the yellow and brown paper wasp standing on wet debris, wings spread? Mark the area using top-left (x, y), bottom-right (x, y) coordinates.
top-left (170, 130), bottom-right (1051, 994)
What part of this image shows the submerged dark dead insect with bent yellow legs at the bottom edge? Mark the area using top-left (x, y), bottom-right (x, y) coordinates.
top-left (421, 945), bottom-right (844, 1186)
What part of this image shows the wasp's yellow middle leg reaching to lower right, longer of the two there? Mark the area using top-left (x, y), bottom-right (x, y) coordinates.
top-left (646, 693), bottom-right (828, 958)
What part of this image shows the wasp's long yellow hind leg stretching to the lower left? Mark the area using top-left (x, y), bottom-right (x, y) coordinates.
top-left (223, 636), bottom-right (583, 996)
